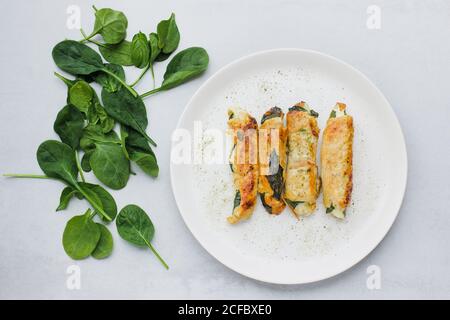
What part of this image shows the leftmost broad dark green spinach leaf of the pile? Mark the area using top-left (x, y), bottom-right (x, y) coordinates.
top-left (36, 140), bottom-right (78, 186)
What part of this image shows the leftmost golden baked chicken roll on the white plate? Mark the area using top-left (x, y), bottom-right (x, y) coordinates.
top-left (227, 108), bottom-right (259, 224)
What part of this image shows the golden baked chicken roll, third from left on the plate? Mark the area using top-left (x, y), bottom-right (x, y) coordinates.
top-left (284, 101), bottom-right (320, 218)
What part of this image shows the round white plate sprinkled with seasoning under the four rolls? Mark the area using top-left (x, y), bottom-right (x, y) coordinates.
top-left (170, 49), bottom-right (407, 284)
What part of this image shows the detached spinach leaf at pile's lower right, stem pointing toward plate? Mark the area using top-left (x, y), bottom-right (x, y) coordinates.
top-left (116, 204), bottom-right (169, 269)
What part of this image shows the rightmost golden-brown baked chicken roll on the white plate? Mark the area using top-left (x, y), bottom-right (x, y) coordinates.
top-left (320, 103), bottom-right (354, 219)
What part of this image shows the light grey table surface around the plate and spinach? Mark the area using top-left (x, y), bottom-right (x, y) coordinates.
top-left (0, 0), bottom-right (450, 299)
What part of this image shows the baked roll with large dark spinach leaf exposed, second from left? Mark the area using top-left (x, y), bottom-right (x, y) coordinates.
top-left (258, 107), bottom-right (287, 214)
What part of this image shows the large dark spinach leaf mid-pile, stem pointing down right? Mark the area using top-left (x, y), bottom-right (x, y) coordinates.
top-left (102, 88), bottom-right (156, 146)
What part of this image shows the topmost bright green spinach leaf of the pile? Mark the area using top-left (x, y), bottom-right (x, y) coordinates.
top-left (86, 8), bottom-right (128, 44)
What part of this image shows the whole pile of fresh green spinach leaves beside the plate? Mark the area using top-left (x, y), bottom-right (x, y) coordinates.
top-left (5, 7), bottom-right (209, 269)
